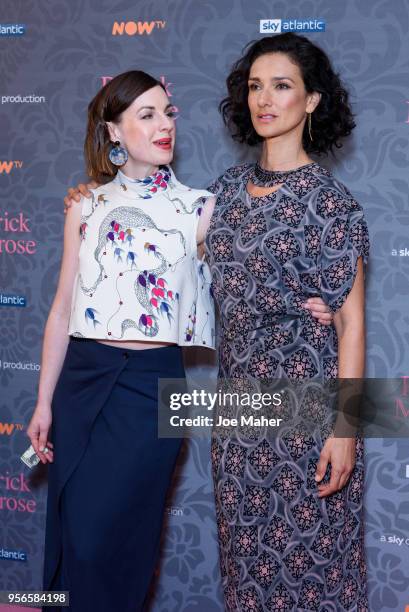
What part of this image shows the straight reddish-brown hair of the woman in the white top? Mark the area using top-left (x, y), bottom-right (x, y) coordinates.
top-left (84, 70), bottom-right (166, 183)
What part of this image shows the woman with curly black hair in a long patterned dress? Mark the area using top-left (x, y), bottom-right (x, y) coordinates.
top-left (206, 33), bottom-right (369, 612)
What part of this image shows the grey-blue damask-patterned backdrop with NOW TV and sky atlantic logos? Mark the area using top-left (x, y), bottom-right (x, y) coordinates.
top-left (0, 0), bottom-right (409, 612)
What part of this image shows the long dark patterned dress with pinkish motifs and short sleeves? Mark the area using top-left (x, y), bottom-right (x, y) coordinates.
top-left (206, 163), bottom-right (369, 612)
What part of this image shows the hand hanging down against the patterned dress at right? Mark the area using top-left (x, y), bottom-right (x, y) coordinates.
top-left (315, 438), bottom-right (356, 497)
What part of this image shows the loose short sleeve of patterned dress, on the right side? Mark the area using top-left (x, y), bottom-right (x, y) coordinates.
top-left (317, 190), bottom-right (369, 312)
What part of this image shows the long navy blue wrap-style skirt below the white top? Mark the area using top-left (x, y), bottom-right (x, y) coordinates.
top-left (44, 338), bottom-right (185, 612)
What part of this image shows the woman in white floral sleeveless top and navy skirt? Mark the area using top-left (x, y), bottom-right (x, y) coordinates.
top-left (28, 71), bottom-right (214, 612)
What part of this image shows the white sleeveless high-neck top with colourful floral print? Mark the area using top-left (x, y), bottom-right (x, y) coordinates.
top-left (68, 166), bottom-right (215, 348)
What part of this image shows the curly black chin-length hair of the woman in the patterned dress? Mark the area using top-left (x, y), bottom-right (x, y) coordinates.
top-left (219, 32), bottom-right (355, 155)
